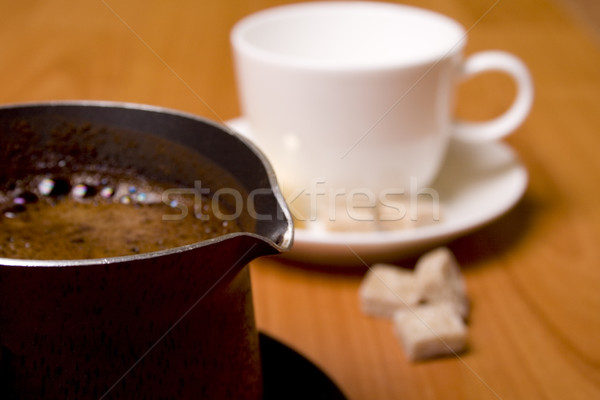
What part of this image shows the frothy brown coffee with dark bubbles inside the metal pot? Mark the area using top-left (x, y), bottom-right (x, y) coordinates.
top-left (0, 173), bottom-right (240, 260)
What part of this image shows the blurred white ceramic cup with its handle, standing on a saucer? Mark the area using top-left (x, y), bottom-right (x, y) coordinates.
top-left (231, 2), bottom-right (533, 198)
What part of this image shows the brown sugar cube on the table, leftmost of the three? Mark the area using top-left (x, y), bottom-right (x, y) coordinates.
top-left (359, 264), bottom-right (419, 318)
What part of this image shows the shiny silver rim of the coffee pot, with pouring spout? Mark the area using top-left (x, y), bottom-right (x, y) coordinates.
top-left (0, 100), bottom-right (294, 267)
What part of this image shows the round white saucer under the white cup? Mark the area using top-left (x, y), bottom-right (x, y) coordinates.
top-left (227, 118), bottom-right (528, 265)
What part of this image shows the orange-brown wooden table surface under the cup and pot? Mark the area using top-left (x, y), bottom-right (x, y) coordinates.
top-left (0, 0), bottom-right (600, 400)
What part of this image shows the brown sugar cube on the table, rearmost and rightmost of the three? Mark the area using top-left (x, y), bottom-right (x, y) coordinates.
top-left (415, 247), bottom-right (469, 318)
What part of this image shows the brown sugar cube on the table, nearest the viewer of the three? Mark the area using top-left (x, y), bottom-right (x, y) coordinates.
top-left (393, 302), bottom-right (467, 361)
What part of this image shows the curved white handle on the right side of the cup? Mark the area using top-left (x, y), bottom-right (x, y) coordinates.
top-left (453, 50), bottom-right (533, 142)
